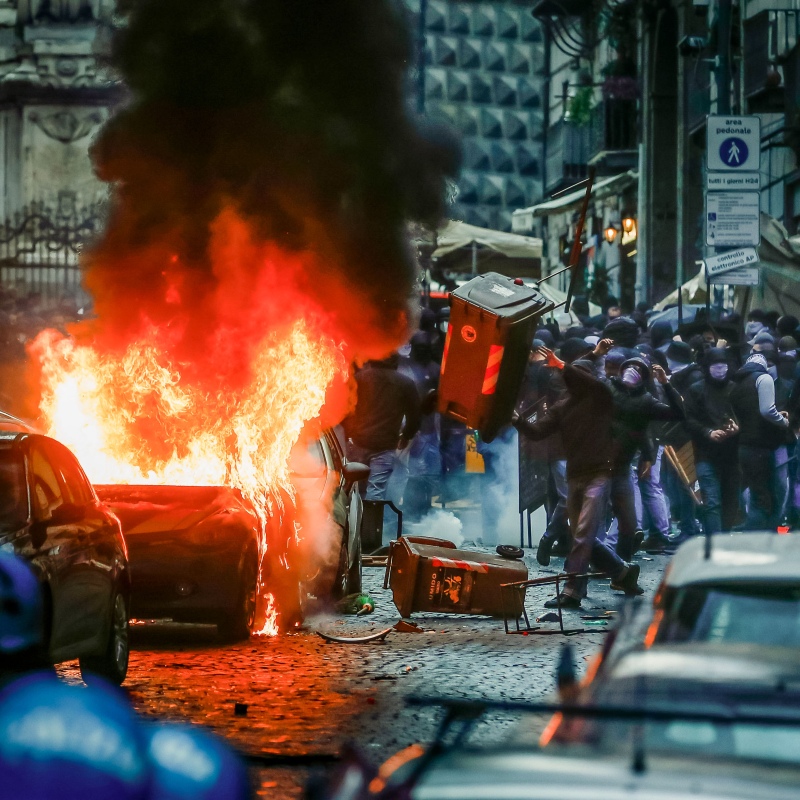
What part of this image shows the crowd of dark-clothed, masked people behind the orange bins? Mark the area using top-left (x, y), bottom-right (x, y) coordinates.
top-left (345, 298), bottom-right (800, 606)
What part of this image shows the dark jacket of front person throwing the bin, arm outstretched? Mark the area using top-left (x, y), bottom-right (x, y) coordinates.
top-left (515, 365), bottom-right (614, 480)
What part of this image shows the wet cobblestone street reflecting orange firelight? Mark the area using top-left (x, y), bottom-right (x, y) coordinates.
top-left (63, 555), bottom-right (667, 797)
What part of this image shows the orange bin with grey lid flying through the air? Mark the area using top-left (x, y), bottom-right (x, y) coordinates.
top-left (439, 272), bottom-right (552, 442)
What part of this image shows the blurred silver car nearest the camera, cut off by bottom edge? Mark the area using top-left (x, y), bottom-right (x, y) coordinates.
top-left (314, 700), bottom-right (800, 800)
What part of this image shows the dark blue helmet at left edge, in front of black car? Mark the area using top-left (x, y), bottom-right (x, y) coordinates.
top-left (0, 553), bottom-right (44, 661)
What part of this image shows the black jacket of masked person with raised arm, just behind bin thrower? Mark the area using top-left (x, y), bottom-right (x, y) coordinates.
top-left (609, 378), bottom-right (686, 474)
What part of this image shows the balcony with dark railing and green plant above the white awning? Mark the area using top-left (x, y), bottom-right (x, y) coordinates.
top-left (588, 99), bottom-right (639, 175)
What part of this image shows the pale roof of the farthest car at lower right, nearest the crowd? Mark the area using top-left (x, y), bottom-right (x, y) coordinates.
top-left (665, 532), bottom-right (800, 588)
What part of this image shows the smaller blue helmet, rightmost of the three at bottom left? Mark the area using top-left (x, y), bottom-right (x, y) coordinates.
top-left (148, 723), bottom-right (250, 800)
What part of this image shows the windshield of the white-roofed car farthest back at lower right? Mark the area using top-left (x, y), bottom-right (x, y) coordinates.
top-left (656, 585), bottom-right (800, 648)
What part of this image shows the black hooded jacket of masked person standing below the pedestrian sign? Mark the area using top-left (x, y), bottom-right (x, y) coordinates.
top-left (684, 378), bottom-right (739, 462)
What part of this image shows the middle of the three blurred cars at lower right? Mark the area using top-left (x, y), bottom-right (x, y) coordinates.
top-left (540, 642), bottom-right (800, 769)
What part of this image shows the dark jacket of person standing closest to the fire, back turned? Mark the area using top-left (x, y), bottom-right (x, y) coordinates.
top-left (344, 362), bottom-right (421, 452)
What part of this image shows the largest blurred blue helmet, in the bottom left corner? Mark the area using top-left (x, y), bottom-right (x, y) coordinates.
top-left (0, 673), bottom-right (150, 800)
